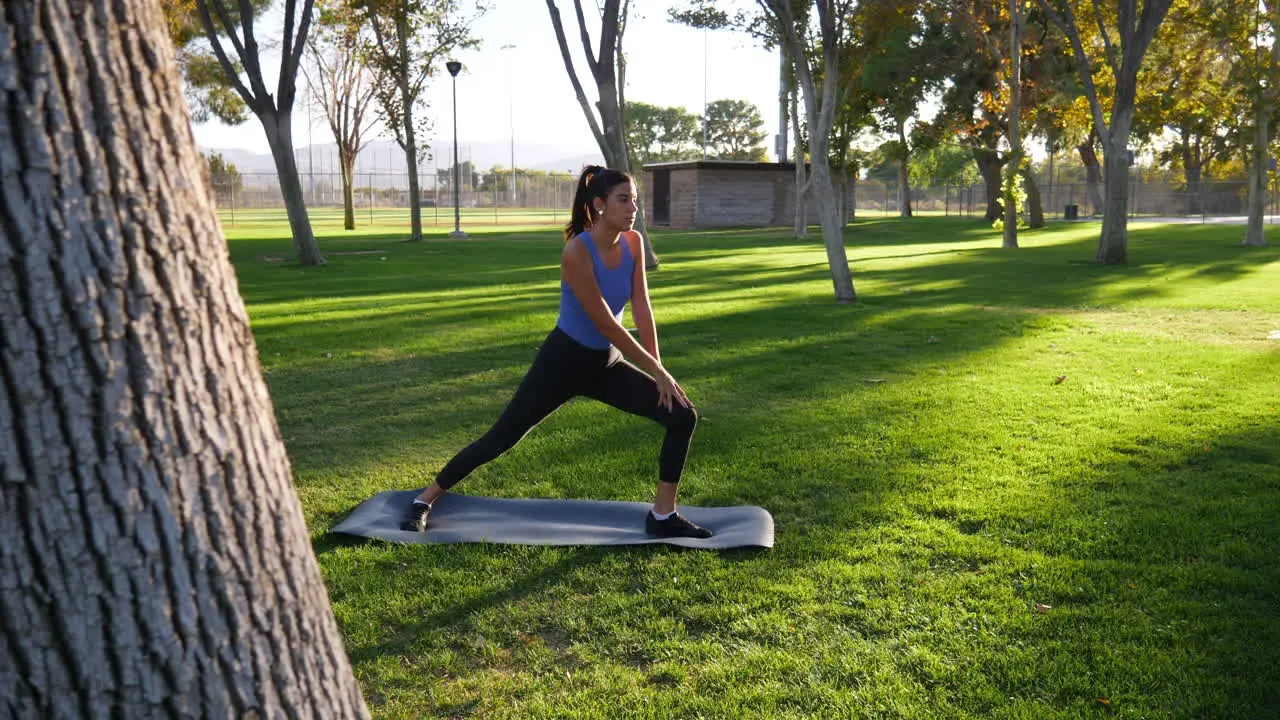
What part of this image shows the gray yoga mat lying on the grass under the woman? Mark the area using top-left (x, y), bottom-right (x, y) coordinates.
top-left (333, 491), bottom-right (773, 550)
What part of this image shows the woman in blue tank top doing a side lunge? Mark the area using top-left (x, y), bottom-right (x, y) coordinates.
top-left (401, 165), bottom-right (712, 538)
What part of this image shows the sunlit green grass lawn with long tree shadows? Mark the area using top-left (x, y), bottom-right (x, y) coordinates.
top-left (228, 212), bottom-right (1280, 719)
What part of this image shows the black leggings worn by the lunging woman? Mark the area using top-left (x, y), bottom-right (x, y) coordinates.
top-left (435, 328), bottom-right (698, 489)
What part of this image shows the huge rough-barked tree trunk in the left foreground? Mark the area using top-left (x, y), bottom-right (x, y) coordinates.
top-left (0, 0), bottom-right (367, 719)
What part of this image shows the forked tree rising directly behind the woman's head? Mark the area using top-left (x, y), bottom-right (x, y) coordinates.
top-left (547, 0), bottom-right (658, 270)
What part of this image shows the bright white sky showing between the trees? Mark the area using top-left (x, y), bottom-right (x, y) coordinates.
top-left (193, 0), bottom-right (778, 165)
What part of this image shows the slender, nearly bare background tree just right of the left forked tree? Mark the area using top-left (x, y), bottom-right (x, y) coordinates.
top-left (302, 0), bottom-right (376, 231)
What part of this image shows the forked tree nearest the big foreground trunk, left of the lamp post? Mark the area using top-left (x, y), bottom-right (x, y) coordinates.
top-left (196, 0), bottom-right (324, 265)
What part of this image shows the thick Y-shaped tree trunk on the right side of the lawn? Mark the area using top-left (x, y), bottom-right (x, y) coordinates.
top-left (1037, 0), bottom-right (1172, 264)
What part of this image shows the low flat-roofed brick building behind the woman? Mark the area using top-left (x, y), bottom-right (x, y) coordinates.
top-left (640, 160), bottom-right (852, 228)
